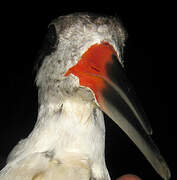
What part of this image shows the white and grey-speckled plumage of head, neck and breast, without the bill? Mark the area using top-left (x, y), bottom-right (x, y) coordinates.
top-left (0, 14), bottom-right (125, 180)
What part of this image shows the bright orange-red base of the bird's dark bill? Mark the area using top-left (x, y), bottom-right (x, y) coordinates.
top-left (65, 42), bottom-right (117, 102)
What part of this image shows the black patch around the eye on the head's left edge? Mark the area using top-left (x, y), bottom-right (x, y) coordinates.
top-left (35, 24), bottom-right (58, 71)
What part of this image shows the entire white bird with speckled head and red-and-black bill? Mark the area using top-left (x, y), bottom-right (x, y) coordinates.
top-left (0, 13), bottom-right (170, 180)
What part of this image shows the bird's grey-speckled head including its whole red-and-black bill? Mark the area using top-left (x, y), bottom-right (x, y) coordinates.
top-left (36, 13), bottom-right (170, 179)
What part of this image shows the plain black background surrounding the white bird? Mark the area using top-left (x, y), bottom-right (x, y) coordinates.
top-left (0, 1), bottom-right (176, 180)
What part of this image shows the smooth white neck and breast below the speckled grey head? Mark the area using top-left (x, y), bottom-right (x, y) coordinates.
top-left (0, 94), bottom-right (109, 180)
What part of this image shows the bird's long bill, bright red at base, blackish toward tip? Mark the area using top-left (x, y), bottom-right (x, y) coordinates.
top-left (65, 43), bottom-right (170, 180)
